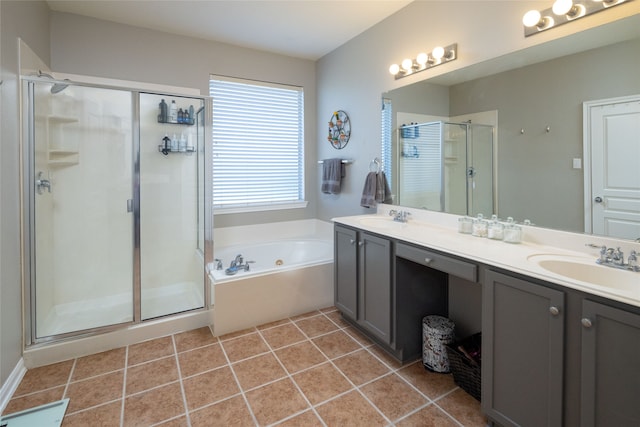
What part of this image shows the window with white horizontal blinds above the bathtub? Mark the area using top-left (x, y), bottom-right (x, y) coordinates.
top-left (209, 76), bottom-right (306, 213)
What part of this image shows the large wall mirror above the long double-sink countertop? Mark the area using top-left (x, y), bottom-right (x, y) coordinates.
top-left (382, 17), bottom-right (640, 239)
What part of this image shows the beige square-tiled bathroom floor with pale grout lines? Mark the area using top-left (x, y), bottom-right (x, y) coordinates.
top-left (4, 307), bottom-right (487, 427)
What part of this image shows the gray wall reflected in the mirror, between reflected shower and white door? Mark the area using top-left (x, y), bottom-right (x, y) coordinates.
top-left (450, 40), bottom-right (640, 232)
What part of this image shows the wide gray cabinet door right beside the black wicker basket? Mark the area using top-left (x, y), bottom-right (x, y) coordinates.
top-left (482, 271), bottom-right (564, 427)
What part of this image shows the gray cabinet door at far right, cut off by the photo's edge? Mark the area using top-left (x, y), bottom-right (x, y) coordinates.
top-left (580, 300), bottom-right (640, 427)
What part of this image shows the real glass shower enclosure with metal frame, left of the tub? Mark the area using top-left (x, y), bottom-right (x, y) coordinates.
top-left (22, 76), bottom-right (211, 344)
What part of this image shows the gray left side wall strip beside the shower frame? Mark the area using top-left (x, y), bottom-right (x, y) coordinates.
top-left (0, 0), bottom-right (49, 384)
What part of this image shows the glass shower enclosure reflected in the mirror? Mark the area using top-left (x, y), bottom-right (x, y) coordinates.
top-left (397, 121), bottom-right (495, 216)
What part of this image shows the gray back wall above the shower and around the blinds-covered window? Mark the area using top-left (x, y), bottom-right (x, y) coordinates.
top-left (51, 11), bottom-right (319, 231)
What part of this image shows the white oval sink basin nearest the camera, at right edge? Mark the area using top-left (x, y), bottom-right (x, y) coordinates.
top-left (527, 254), bottom-right (640, 294)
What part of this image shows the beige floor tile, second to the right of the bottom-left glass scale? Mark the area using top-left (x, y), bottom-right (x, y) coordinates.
top-left (124, 383), bottom-right (186, 426)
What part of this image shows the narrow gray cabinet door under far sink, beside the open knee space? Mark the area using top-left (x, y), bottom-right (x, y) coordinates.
top-left (359, 233), bottom-right (391, 344)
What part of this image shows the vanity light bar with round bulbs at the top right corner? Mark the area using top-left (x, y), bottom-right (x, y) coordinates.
top-left (522, 0), bottom-right (632, 37)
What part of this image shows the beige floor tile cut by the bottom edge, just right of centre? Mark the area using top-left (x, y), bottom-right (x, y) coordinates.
top-left (316, 391), bottom-right (387, 427)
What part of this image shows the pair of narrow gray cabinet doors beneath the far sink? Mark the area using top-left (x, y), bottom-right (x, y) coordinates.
top-left (334, 225), bottom-right (392, 344)
